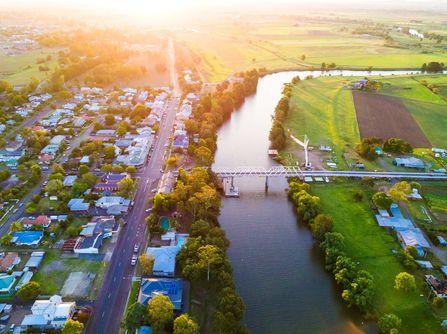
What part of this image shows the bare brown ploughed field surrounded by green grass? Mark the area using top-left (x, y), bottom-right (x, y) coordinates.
top-left (352, 91), bottom-right (431, 147)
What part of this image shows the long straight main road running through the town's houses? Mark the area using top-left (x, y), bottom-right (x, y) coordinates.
top-left (86, 37), bottom-right (180, 334)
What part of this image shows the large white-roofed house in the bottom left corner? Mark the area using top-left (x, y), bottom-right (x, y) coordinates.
top-left (21, 295), bottom-right (76, 330)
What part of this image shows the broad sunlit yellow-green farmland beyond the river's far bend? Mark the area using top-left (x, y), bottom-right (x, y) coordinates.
top-left (176, 11), bottom-right (447, 81)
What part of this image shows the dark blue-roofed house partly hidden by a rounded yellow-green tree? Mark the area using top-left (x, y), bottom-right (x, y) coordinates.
top-left (138, 278), bottom-right (183, 311)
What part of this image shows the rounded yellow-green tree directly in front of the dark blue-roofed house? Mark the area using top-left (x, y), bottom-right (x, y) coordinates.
top-left (148, 295), bottom-right (174, 333)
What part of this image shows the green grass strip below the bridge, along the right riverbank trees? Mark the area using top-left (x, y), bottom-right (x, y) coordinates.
top-left (312, 183), bottom-right (444, 333)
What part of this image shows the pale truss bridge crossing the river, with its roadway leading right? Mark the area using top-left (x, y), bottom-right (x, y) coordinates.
top-left (213, 166), bottom-right (447, 188)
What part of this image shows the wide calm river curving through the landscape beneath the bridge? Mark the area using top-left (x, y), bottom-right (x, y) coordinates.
top-left (214, 71), bottom-right (424, 334)
